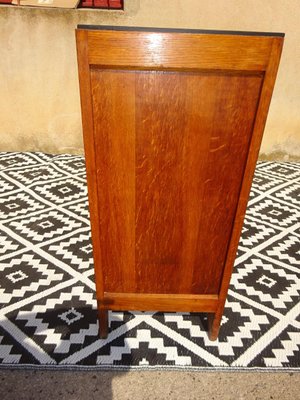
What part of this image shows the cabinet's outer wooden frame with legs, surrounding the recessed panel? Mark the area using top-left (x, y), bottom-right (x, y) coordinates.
top-left (76, 26), bottom-right (284, 340)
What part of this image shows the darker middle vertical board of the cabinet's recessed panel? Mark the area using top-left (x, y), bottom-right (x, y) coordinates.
top-left (136, 71), bottom-right (188, 293)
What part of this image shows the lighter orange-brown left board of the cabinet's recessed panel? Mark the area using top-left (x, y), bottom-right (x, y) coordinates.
top-left (91, 68), bottom-right (135, 292)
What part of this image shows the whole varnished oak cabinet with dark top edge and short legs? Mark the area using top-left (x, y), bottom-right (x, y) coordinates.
top-left (76, 26), bottom-right (283, 339)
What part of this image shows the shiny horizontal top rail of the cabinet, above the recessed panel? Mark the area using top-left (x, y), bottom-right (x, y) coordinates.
top-left (88, 31), bottom-right (273, 71)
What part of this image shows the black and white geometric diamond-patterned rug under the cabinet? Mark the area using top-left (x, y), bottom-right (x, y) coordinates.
top-left (0, 153), bottom-right (300, 370)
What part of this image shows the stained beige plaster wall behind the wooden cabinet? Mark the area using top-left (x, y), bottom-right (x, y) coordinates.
top-left (0, 0), bottom-right (300, 159)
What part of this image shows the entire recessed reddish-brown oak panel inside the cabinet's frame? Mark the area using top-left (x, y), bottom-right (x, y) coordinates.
top-left (91, 69), bottom-right (262, 294)
